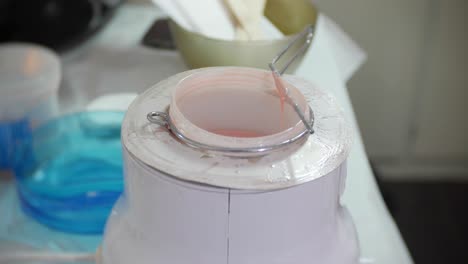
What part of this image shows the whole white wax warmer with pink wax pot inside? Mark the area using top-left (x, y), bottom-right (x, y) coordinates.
top-left (101, 67), bottom-right (359, 264)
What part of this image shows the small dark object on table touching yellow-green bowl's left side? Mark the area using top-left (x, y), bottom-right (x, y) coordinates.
top-left (142, 18), bottom-right (176, 50)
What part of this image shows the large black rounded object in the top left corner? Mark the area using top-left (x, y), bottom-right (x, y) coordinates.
top-left (0, 0), bottom-right (122, 51)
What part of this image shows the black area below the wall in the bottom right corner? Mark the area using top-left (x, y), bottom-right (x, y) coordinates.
top-left (381, 182), bottom-right (468, 264)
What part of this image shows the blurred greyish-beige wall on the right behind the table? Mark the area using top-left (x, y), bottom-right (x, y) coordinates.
top-left (314, 0), bottom-right (468, 181)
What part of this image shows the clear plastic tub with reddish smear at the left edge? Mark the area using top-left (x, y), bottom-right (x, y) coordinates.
top-left (0, 43), bottom-right (61, 170)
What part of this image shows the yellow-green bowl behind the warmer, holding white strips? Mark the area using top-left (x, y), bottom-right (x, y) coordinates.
top-left (169, 0), bottom-right (317, 72)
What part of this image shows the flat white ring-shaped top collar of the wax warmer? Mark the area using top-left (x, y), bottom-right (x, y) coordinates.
top-left (122, 67), bottom-right (352, 191)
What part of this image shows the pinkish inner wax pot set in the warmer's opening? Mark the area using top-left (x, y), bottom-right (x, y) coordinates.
top-left (169, 68), bottom-right (307, 145)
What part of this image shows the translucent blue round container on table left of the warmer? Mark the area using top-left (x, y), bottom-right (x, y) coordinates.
top-left (14, 112), bottom-right (123, 233)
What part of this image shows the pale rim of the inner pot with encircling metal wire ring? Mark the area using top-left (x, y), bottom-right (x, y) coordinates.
top-left (148, 68), bottom-right (314, 156)
